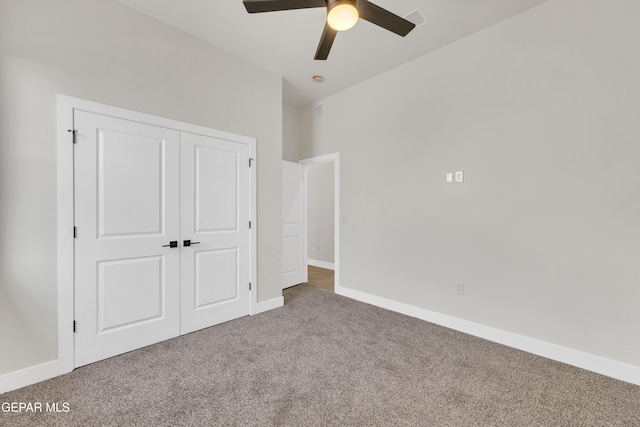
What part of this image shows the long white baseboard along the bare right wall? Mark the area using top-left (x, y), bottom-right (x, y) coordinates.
top-left (335, 286), bottom-right (640, 385)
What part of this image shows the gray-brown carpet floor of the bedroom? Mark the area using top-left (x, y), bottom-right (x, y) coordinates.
top-left (0, 285), bottom-right (640, 426)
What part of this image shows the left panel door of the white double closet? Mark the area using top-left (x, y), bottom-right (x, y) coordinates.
top-left (74, 111), bottom-right (181, 366)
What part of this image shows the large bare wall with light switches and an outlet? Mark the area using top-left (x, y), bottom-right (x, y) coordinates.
top-left (300, 0), bottom-right (640, 367)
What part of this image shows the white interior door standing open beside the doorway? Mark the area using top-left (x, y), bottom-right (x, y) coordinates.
top-left (282, 161), bottom-right (306, 288)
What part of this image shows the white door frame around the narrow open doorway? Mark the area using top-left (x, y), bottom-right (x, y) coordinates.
top-left (298, 153), bottom-right (342, 293)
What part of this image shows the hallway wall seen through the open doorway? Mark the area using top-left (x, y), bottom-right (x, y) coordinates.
top-left (307, 162), bottom-right (335, 264)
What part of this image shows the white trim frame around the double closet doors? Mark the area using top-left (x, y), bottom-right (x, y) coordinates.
top-left (57, 94), bottom-right (255, 375)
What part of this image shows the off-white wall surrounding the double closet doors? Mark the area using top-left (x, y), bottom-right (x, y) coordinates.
top-left (0, 0), bottom-right (282, 374)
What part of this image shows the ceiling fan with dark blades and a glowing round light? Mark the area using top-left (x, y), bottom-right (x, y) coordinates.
top-left (243, 0), bottom-right (415, 60)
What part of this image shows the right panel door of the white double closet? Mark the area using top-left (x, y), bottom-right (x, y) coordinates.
top-left (180, 132), bottom-right (251, 334)
